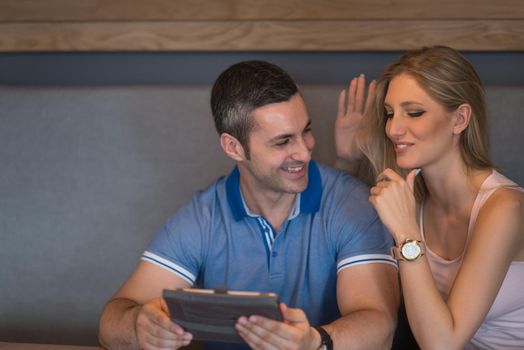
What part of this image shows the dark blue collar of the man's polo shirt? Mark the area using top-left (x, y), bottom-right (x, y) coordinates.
top-left (226, 160), bottom-right (322, 221)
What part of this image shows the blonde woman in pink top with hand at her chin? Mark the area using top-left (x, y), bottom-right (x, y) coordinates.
top-left (335, 47), bottom-right (524, 349)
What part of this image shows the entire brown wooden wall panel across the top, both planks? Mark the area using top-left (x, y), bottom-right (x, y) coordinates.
top-left (0, 0), bottom-right (524, 52)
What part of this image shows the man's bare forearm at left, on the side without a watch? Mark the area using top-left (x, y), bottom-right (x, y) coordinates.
top-left (98, 298), bottom-right (141, 350)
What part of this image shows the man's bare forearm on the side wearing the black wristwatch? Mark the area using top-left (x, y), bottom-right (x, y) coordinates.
top-left (323, 310), bottom-right (396, 350)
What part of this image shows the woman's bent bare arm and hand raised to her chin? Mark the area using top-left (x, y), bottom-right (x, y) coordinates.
top-left (370, 170), bottom-right (524, 349)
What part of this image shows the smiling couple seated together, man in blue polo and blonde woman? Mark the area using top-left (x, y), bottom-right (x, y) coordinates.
top-left (100, 47), bottom-right (524, 349)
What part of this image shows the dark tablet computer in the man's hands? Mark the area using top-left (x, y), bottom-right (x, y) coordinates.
top-left (162, 288), bottom-right (282, 343)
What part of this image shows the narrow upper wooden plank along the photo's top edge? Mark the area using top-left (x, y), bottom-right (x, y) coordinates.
top-left (0, 0), bottom-right (524, 22)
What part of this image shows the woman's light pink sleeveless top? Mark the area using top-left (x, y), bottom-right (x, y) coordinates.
top-left (419, 170), bottom-right (524, 350)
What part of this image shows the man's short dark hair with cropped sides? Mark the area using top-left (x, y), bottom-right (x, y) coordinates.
top-left (211, 61), bottom-right (298, 156)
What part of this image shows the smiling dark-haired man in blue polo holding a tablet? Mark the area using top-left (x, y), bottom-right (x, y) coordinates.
top-left (100, 61), bottom-right (398, 350)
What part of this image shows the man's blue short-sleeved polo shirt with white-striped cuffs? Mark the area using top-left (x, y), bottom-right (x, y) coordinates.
top-left (142, 161), bottom-right (396, 324)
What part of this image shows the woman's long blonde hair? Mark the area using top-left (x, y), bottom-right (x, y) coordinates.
top-left (358, 46), bottom-right (492, 200)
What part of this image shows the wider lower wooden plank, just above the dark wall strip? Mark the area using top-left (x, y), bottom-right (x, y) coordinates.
top-left (0, 20), bottom-right (524, 52)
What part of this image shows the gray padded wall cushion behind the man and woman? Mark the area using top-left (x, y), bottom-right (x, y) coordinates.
top-left (0, 85), bottom-right (524, 345)
